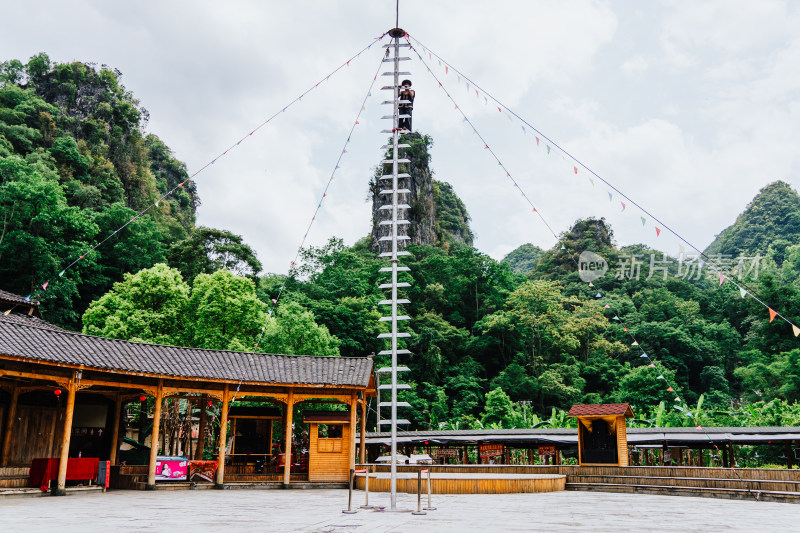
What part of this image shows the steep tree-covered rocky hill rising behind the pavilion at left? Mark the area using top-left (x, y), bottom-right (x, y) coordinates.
top-left (0, 54), bottom-right (261, 329)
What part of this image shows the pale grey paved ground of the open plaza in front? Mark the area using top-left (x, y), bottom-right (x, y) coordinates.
top-left (0, 489), bottom-right (800, 533)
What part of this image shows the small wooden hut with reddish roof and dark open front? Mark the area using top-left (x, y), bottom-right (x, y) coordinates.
top-left (567, 403), bottom-right (633, 466)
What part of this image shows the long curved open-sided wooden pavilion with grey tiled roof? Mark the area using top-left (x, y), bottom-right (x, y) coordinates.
top-left (0, 291), bottom-right (376, 494)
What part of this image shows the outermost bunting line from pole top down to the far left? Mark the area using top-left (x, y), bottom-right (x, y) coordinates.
top-left (4, 33), bottom-right (386, 314)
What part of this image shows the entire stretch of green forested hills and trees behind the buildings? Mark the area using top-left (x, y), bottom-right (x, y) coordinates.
top-left (0, 54), bottom-right (800, 436)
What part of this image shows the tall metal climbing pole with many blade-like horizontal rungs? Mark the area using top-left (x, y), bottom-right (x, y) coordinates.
top-left (378, 28), bottom-right (411, 511)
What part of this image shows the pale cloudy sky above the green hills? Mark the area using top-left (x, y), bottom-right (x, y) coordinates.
top-left (0, 0), bottom-right (800, 272)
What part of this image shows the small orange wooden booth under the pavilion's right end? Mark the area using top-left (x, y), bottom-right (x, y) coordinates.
top-left (303, 411), bottom-right (355, 483)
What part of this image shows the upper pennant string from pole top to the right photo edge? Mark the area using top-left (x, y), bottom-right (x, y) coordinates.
top-left (406, 35), bottom-right (800, 337)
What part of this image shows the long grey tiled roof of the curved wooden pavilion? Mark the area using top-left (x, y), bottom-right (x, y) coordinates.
top-left (0, 315), bottom-right (372, 387)
